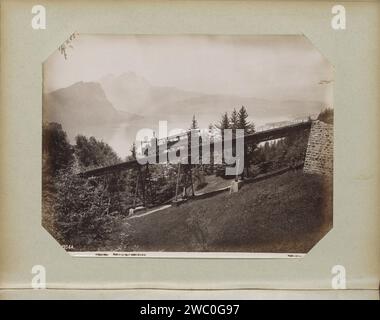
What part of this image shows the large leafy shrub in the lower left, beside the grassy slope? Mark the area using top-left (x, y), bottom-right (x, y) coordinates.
top-left (51, 165), bottom-right (118, 250)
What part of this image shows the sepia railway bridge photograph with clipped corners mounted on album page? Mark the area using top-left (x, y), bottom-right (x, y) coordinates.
top-left (41, 33), bottom-right (334, 257)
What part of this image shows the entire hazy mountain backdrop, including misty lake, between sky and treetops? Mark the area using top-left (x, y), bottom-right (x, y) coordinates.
top-left (43, 72), bottom-right (323, 157)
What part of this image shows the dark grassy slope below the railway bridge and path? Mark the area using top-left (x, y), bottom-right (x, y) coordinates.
top-left (123, 171), bottom-right (332, 253)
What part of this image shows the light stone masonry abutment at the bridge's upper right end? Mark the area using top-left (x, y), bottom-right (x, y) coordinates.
top-left (303, 120), bottom-right (334, 175)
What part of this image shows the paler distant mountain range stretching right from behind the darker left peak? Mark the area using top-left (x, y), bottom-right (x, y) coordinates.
top-left (99, 72), bottom-right (322, 129)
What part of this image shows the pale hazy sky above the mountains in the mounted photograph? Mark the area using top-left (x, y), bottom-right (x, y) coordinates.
top-left (44, 34), bottom-right (333, 107)
